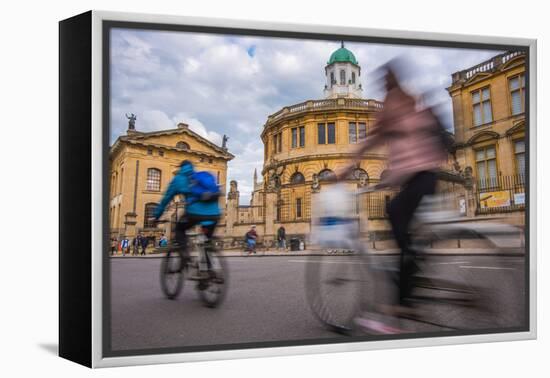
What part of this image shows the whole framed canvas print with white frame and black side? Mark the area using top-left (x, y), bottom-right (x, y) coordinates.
top-left (59, 11), bottom-right (536, 367)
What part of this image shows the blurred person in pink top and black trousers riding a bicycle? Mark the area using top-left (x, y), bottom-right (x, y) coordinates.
top-left (338, 65), bottom-right (447, 314)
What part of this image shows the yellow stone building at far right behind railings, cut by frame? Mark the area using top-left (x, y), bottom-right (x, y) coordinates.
top-left (447, 48), bottom-right (527, 225)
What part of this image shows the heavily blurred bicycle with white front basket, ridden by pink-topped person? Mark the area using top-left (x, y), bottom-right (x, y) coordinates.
top-left (306, 187), bottom-right (520, 335)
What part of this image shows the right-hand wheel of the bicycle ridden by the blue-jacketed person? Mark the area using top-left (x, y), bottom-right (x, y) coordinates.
top-left (198, 252), bottom-right (228, 307)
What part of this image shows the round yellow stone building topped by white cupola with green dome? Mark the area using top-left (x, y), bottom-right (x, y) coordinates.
top-left (226, 44), bottom-right (389, 245)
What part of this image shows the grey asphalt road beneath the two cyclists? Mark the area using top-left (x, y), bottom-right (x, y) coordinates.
top-left (111, 256), bottom-right (525, 351)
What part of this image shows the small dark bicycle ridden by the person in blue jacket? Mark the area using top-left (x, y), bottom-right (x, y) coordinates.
top-left (160, 221), bottom-right (228, 307)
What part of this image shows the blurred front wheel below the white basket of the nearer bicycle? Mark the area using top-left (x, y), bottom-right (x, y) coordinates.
top-left (306, 254), bottom-right (367, 333)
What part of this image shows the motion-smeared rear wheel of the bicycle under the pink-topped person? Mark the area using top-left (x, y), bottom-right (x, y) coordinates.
top-left (412, 226), bottom-right (521, 331)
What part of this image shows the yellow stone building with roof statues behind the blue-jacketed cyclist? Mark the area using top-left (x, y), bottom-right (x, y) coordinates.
top-left (109, 122), bottom-right (233, 244)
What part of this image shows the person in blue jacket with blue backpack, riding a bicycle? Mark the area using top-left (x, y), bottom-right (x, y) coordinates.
top-left (154, 160), bottom-right (221, 264)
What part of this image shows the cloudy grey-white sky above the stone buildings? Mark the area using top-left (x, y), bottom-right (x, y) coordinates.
top-left (111, 29), bottom-right (506, 204)
